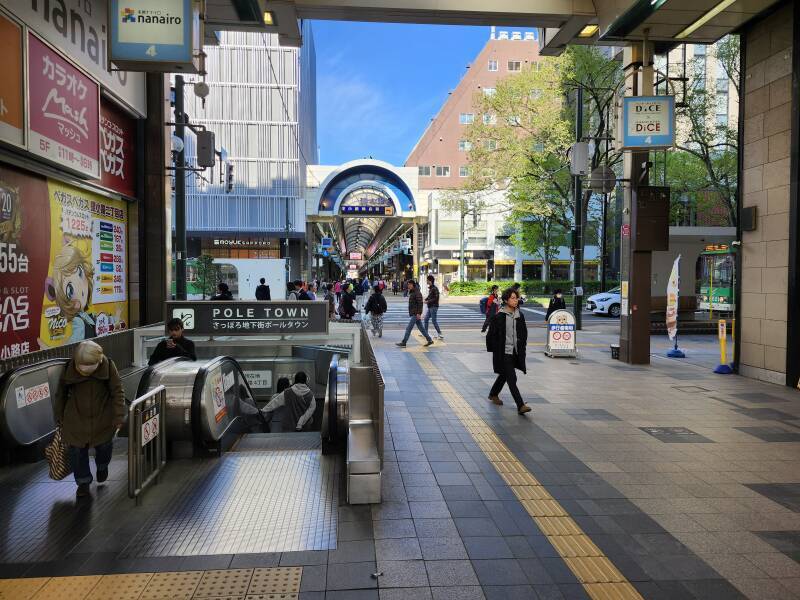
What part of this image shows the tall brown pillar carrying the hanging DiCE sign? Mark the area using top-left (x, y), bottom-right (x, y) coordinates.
top-left (619, 44), bottom-right (653, 364)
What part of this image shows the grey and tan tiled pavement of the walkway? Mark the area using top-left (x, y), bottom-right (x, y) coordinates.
top-left (0, 331), bottom-right (800, 600)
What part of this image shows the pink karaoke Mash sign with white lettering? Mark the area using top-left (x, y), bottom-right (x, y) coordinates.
top-left (28, 33), bottom-right (100, 179)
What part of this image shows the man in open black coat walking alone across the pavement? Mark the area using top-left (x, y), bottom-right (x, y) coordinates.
top-left (486, 288), bottom-right (531, 415)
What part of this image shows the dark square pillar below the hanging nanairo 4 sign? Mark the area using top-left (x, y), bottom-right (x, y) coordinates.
top-left (138, 73), bottom-right (172, 325)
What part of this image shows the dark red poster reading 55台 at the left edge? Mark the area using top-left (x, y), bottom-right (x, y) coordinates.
top-left (0, 165), bottom-right (50, 359)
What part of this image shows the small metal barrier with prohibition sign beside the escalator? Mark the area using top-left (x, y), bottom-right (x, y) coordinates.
top-left (128, 385), bottom-right (167, 506)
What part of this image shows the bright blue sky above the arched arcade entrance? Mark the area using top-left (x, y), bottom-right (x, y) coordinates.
top-left (312, 21), bottom-right (490, 165)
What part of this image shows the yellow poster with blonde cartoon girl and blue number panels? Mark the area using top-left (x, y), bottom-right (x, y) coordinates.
top-left (39, 180), bottom-right (128, 347)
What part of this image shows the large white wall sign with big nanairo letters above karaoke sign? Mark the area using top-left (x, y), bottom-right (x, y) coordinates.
top-left (0, 0), bottom-right (147, 116)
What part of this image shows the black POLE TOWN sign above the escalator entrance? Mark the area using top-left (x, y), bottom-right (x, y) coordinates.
top-left (164, 300), bottom-right (328, 336)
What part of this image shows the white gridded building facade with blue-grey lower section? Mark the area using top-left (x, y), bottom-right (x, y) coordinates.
top-left (180, 27), bottom-right (318, 233)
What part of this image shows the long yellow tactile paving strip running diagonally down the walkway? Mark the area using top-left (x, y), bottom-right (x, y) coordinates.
top-left (415, 354), bottom-right (642, 600)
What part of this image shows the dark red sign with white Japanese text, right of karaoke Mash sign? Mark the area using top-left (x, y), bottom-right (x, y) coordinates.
top-left (100, 98), bottom-right (136, 196)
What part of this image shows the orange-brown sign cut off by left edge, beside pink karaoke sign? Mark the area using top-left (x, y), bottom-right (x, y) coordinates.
top-left (0, 13), bottom-right (25, 146)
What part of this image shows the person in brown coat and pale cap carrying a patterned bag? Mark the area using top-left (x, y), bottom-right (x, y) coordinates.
top-left (53, 340), bottom-right (126, 498)
